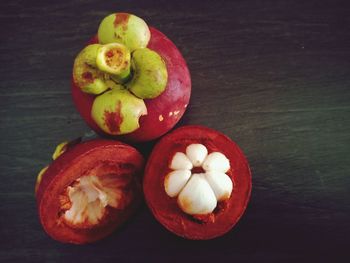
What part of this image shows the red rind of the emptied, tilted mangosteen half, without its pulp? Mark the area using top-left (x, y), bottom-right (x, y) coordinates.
top-left (36, 140), bottom-right (144, 244)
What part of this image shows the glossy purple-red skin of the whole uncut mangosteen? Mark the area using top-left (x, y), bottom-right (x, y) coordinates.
top-left (72, 27), bottom-right (191, 142)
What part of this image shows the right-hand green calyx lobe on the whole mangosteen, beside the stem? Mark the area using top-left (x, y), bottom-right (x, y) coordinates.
top-left (127, 48), bottom-right (168, 99)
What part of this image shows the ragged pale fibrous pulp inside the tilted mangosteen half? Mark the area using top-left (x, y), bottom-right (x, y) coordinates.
top-left (64, 175), bottom-right (127, 225)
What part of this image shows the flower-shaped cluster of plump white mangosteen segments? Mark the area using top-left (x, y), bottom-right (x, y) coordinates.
top-left (164, 144), bottom-right (233, 215)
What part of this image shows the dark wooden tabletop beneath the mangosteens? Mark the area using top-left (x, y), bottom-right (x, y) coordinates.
top-left (0, 0), bottom-right (350, 262)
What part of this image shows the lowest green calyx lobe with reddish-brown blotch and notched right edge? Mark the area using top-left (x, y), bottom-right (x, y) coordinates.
top-left (91, 84), bottom-right (147, 135)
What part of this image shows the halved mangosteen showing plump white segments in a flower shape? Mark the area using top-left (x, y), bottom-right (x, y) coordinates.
top-left (143, 126), bottom-right (251, 239)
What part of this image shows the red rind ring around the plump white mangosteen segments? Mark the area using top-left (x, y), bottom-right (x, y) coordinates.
top-left (143, 126), bottom-right (252, 240)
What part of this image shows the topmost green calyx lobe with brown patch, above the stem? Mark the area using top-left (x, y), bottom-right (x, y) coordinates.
top-left (97, 13), bottom-right (151, 51)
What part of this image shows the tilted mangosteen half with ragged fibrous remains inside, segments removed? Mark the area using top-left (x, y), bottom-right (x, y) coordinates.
top-left (36, 139), bottom-right (144, 244)
